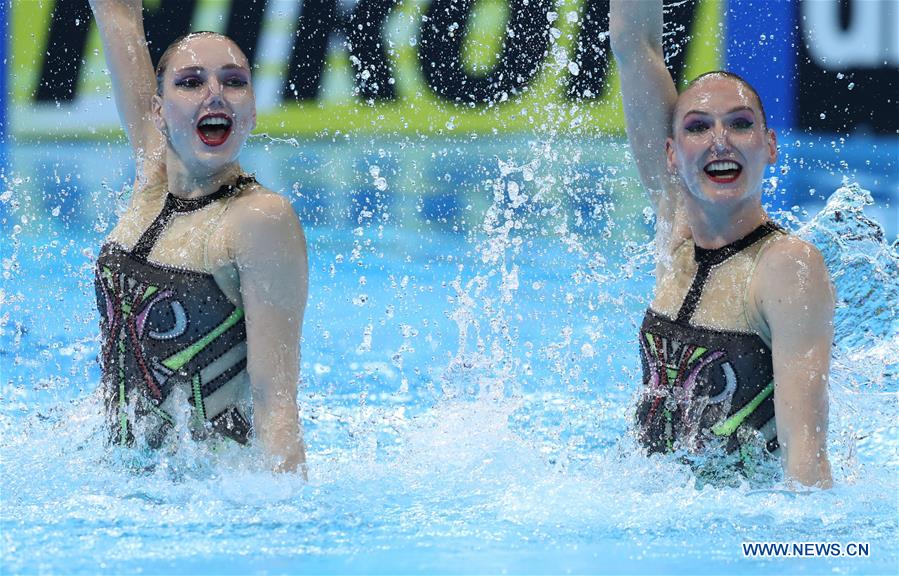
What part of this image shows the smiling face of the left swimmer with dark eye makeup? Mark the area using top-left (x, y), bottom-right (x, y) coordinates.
top-left (153, 34), bottom-right (256, 173)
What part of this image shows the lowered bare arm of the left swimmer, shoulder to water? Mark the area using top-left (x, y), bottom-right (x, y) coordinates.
top-left (229, 194), bottom-right (308, 474)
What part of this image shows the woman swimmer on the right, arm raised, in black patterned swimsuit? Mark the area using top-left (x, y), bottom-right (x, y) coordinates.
top-left (610, 0), bottom-right (834, 487)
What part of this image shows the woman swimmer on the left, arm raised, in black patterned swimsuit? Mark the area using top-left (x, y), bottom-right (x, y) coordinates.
top-left (90, 0), bottom-right (308, 472)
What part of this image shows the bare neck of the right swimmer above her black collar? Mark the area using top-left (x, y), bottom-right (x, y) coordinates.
top-left (684, 197), bottom-right (768, 250)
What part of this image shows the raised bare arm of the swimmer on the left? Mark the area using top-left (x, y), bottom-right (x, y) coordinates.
top-left (90, 0), bottom-right (165, 183)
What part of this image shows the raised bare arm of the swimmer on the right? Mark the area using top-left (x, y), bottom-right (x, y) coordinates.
top-left (609, 0), bottom-right (679, 235)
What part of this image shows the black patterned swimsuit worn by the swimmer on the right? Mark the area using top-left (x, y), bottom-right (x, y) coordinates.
top-left (637, 222), bottom-right (779, 453)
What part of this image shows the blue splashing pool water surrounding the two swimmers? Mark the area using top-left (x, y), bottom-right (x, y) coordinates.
top-left (0, 137), bottom-right (899, 574)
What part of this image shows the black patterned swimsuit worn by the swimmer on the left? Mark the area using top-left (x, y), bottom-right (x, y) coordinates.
top-left (94, 177), bottom-right (254, 447)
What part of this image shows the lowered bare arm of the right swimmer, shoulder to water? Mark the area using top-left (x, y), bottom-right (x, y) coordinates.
top-left (753, 237), bottom-right (834, 488)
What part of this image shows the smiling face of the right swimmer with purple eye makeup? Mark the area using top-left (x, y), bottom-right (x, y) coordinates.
top-left (666, 74), bottom-right (777, 208)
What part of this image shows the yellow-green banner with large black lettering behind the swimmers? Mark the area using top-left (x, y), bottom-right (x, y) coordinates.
top-left (7, 0), bottom-right (722, 138)
